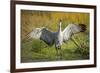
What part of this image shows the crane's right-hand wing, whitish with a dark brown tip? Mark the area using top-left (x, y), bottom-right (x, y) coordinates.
top-left (63, 24), bottom-right (86, 42)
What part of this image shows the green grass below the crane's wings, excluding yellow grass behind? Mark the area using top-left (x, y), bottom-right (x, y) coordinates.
top-left (21, 32), bottom-right (89, 62)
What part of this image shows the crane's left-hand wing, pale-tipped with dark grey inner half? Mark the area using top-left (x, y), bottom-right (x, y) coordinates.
top-left (29, 27), bottom-right (56, 45)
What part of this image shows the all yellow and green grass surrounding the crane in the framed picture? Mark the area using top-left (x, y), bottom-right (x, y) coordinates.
top-left (21, 10), bottom-right (89, 63)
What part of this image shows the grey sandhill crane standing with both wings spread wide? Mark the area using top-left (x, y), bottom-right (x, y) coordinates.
top-left (28, 20), bottom-right (86, 59)
